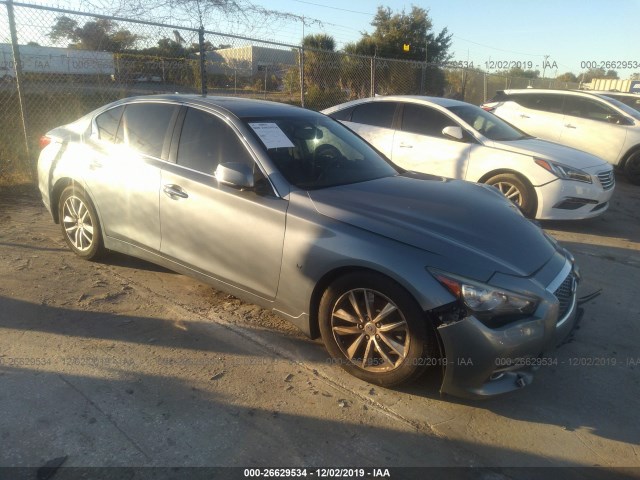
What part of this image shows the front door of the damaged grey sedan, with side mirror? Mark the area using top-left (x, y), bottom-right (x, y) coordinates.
top-left (160, 108), bottom-right (288, 298)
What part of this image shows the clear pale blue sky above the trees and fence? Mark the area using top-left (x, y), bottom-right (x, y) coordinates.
top-left (248, 0), bottom-right (640, 78)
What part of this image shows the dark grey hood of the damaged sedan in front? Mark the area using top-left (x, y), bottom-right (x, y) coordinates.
top-left (308, 172), bottom-right (555, 281)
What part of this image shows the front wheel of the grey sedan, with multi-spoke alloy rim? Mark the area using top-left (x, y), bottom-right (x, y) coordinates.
top-left (319, 272), bottom-right (437, 387)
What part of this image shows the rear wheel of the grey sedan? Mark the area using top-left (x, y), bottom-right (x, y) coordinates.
top-left (58, 185), bottom-right (104, 260)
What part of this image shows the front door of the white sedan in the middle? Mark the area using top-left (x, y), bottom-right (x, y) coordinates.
top-left (391, 103), bottom-right (471, 179)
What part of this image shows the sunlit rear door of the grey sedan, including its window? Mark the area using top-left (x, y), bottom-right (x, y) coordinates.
top-left (85, 103), bottom-right (179, 250)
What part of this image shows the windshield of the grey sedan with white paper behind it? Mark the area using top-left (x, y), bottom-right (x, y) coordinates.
top-left (243, 112), bottom-right (398, 190)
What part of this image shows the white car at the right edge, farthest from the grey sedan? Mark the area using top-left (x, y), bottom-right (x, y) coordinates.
top-left (482, 88), bottom-right (640, 185)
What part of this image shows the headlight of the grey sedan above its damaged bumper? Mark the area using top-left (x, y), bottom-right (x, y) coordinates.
top-left (429, 269), bottom-right (539, 326)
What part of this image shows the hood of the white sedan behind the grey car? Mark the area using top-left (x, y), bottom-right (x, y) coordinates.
top-left (487, 138), bottom-right (607, 168)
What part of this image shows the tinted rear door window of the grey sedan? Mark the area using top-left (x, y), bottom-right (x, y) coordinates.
top-left (117, 103), bottom-right (179, 160)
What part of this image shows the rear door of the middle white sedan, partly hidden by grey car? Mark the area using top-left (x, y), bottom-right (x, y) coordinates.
top-left (342, 102), bottom-right (398, 158)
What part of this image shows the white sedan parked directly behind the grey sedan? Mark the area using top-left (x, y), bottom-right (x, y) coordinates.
top-left (322, 96), bottom-right (615, 220)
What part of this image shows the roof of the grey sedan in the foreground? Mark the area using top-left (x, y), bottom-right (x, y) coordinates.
top-left (109, 94), bottom-right (316, 118)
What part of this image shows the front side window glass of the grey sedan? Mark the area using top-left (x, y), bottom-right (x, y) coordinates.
top-left (178, 108), bottom-right (254, 175)
